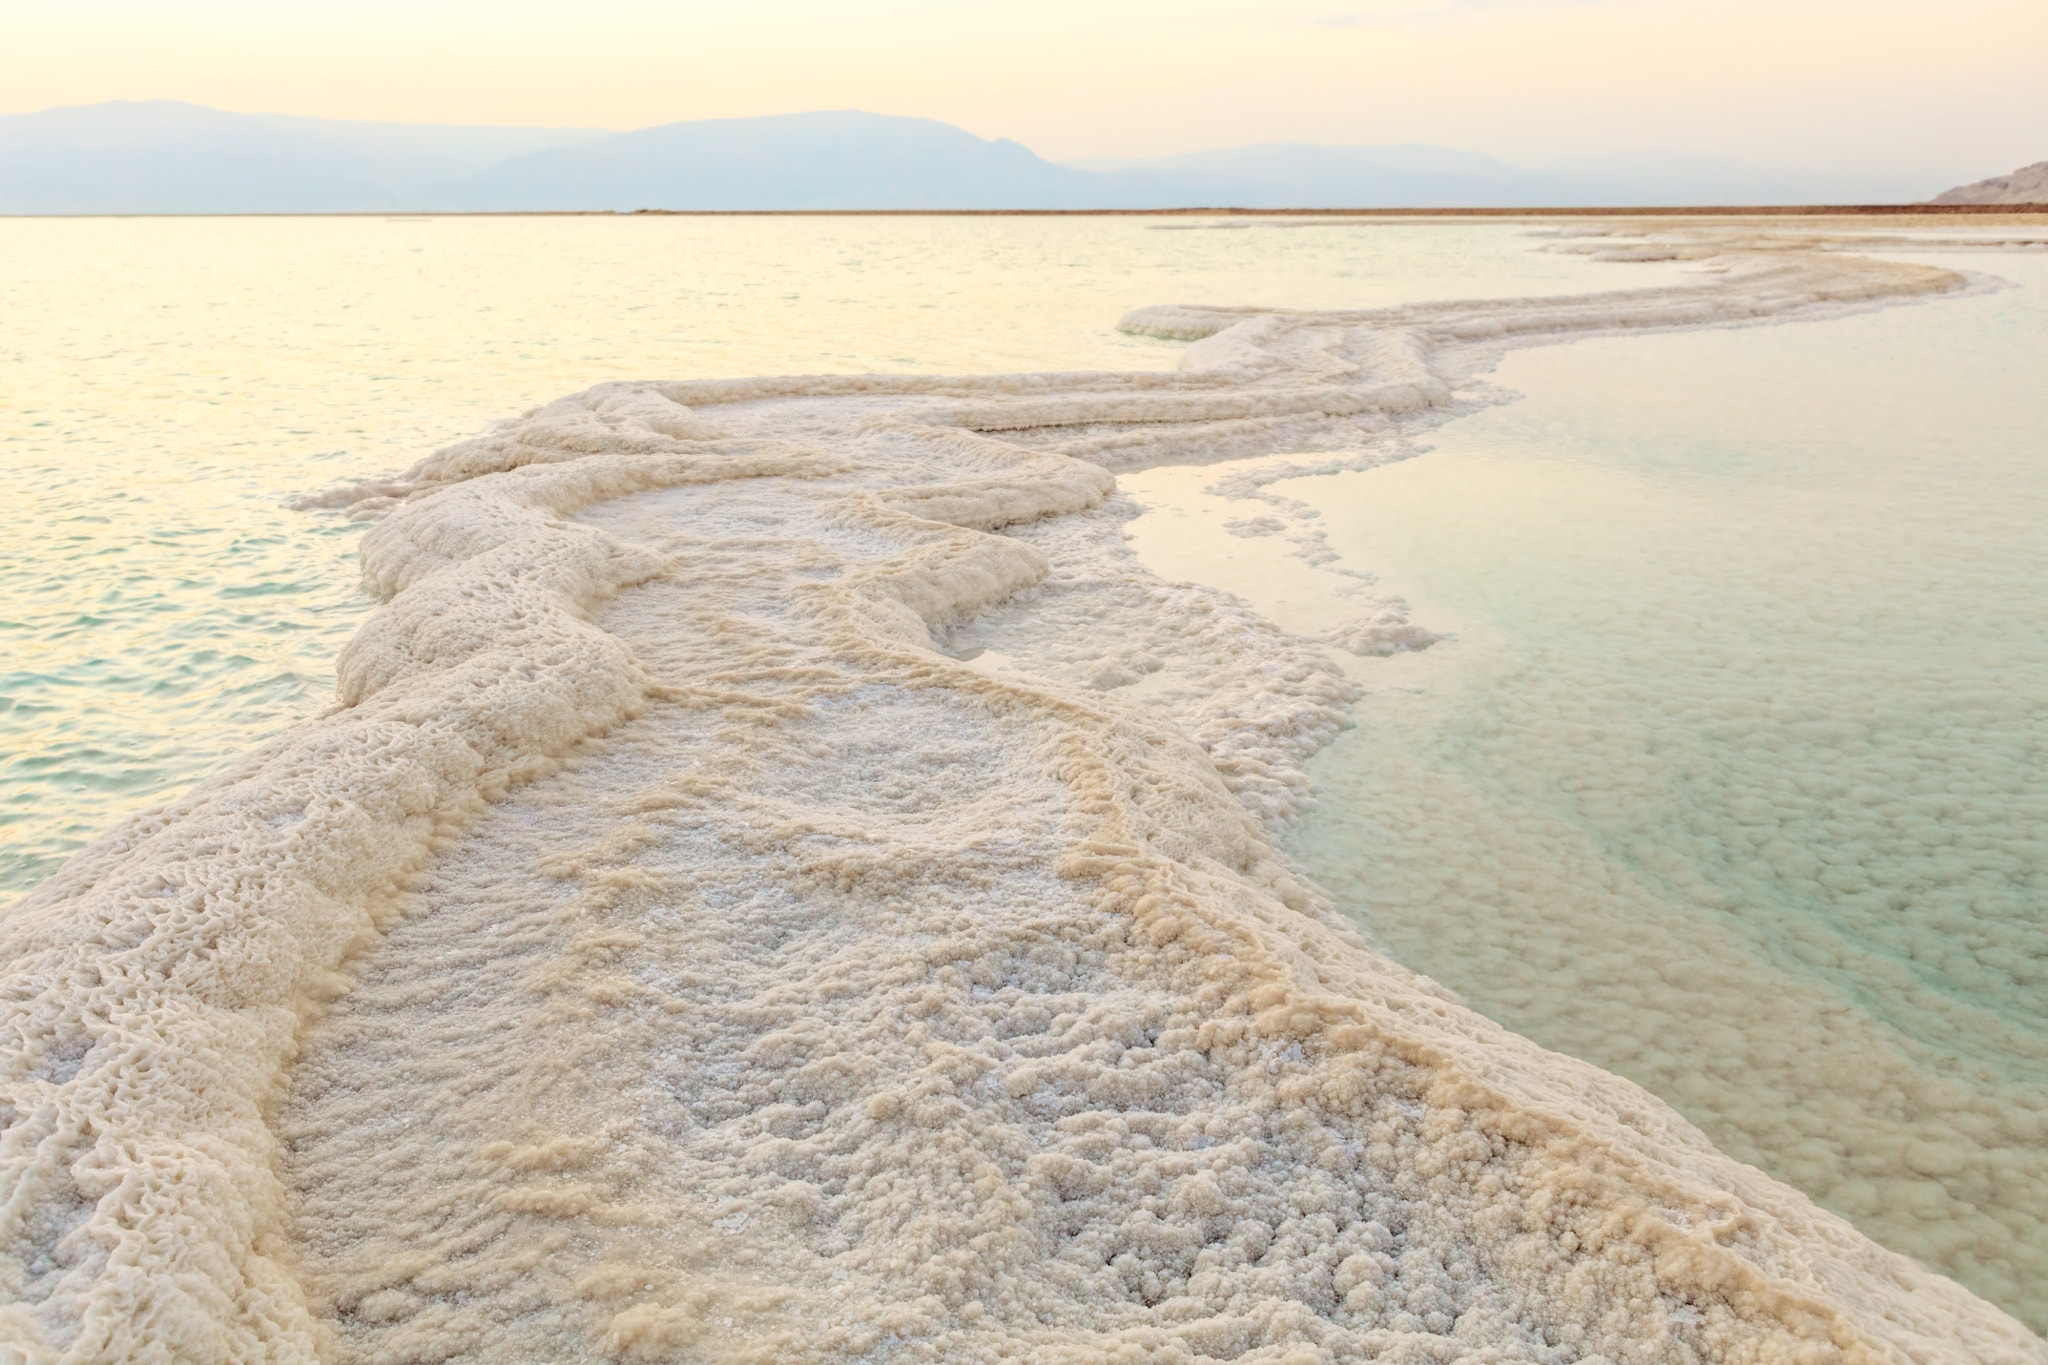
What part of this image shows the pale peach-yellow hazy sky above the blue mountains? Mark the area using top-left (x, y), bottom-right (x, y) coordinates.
top-left (0, 0), bottom-right (2048, 176)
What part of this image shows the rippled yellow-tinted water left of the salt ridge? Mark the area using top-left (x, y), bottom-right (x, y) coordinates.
top-left (0, 217), bottom-right (1665, 900)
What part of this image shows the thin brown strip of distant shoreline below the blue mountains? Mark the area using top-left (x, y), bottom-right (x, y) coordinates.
top-left (0, 205), bottom-right (2048, 219)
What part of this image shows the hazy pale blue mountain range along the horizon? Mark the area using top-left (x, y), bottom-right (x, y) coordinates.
top-left (0, 100), bottom-right (1949, 215)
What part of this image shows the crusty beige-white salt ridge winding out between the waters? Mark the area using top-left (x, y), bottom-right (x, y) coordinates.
top-left (0, 239), bottom-right (2048, 1365)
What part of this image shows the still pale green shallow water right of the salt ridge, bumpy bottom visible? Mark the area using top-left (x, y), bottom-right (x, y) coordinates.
top-left (1124, 258), bottom-right (2048, 1330)
